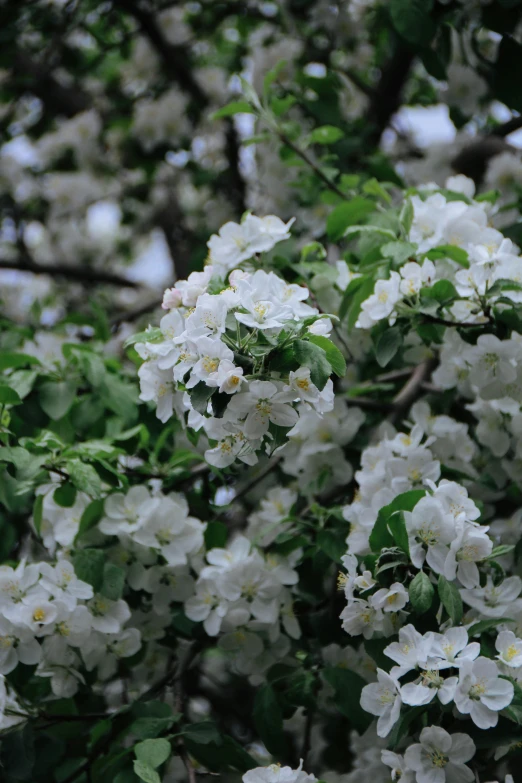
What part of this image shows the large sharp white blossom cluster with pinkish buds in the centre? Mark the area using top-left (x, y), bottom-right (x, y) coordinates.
top-left (136, 215), bottom-right (338, 468)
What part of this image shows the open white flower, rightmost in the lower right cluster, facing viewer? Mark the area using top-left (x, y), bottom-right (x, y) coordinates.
top-left (455, 658), bottom-right (514, 729)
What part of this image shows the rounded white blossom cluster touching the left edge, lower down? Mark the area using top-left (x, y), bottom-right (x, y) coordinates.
top-left (0, 560), bottom-right (141, 697)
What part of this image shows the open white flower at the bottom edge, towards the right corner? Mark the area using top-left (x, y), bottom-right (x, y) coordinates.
top-left (404, 726), bottom-right (476, 783)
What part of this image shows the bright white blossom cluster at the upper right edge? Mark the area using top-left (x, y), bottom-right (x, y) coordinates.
top-left (357, 177), bottom-right (522, 330)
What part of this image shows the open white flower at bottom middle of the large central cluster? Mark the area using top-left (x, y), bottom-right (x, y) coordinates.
top-left (225, 381), bottom-right (298, 438)
